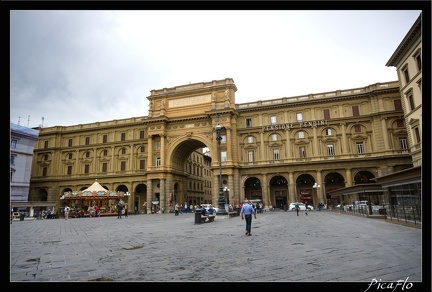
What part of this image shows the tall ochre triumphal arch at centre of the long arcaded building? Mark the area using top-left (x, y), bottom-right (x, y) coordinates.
top-left (143, 78), bottom-right (244, 210)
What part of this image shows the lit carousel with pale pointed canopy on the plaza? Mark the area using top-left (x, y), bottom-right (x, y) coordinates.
top-left (60, 181), bottom-right (129, 217)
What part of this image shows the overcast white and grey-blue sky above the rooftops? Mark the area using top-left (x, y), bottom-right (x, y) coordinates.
top-left (10, 10), bottom-right (421, 127)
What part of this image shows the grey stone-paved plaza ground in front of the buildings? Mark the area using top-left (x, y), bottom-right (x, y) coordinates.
top-left (10, 210), bottom-right (430, 292)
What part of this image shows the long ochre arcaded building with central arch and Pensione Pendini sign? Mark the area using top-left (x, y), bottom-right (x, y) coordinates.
top-left (30, 78), bottom-right (413, 212)
